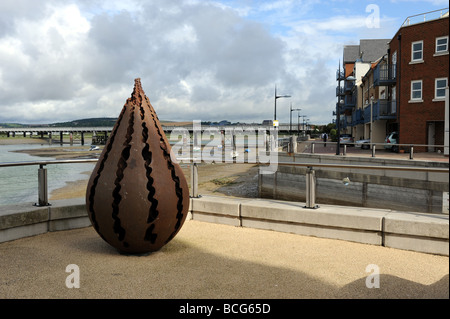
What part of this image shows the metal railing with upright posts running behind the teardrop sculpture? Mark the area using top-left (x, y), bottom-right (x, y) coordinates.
top-left (0, 158), bottom-right (449, 209)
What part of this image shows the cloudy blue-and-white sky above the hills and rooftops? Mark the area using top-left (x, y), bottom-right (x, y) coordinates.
top-left (0, 0), bottom-right (448, 124)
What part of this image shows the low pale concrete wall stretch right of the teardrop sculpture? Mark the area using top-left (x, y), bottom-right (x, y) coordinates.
top-left (190, 196), bottom-right (449, 256)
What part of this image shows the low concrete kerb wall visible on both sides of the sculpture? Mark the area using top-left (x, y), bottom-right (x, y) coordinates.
top-left (0, 196), bottom-right (449, 256)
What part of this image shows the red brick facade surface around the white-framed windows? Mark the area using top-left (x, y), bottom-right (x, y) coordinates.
top-left (390, 17), bottom-right (449, 150)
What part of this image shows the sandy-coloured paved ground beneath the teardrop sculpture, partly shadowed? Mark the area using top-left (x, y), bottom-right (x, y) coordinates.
top-left (0, 220), bottom-right (449, 299)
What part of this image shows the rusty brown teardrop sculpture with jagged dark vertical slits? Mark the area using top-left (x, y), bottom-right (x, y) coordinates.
top-left (86, 79), bottom-right (189, 254)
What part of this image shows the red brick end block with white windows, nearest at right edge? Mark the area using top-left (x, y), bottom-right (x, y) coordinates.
top-left (388, 11), bottom-right (449, 151)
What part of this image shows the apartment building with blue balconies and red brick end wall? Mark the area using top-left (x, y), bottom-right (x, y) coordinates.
top-left (341, 8), bottom-right (449, 151)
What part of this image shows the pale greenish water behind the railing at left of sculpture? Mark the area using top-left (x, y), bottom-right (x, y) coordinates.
top-left (0, 144), bottom-right (95, 205)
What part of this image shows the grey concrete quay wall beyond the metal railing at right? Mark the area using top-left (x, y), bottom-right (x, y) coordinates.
top-left (259, 154), bottom-right (449, 214)
